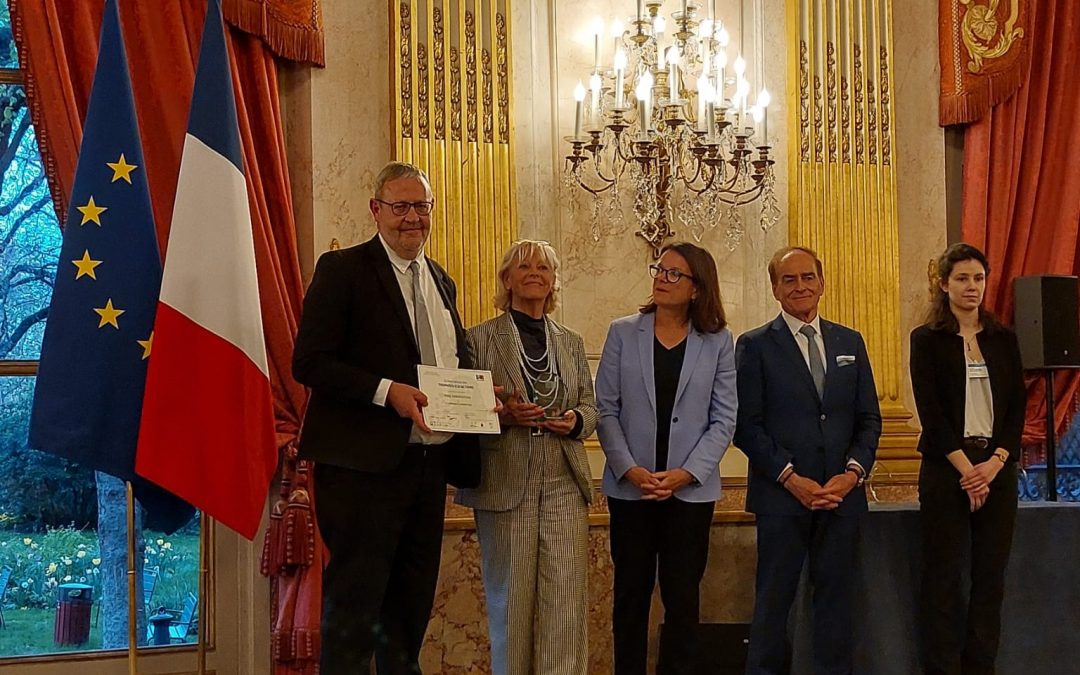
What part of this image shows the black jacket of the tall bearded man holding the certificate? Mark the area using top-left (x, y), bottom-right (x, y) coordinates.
top-left (293, 237), bottom-right (480, 487)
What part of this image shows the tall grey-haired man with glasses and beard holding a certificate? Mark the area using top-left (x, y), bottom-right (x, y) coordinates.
top-left (293, 162), bottom-right (480, 675)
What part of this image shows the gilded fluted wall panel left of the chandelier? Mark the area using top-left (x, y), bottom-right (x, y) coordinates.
top-left (390, 0), bottom-right (517, 325)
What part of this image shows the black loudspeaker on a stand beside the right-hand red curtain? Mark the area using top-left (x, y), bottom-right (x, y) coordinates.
top-left (1013, 274), bottom-right (1080, 370)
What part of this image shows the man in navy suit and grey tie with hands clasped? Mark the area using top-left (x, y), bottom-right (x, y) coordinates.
top-left (734, 246), bottom-right (881, 675)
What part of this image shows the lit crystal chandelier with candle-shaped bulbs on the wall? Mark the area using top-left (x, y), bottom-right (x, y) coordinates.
top-left (563, 0), bottom-right (780, 256)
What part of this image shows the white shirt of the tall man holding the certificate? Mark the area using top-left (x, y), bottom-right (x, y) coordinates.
top-left (372, 234), bottom-right (458, 445)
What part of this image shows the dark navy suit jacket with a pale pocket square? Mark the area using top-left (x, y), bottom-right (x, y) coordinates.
top-left (734, 315), bottom-right (881, 515)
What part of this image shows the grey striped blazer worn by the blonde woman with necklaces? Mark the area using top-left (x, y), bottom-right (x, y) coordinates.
top-left (456, 313), bottom-right (596, 511)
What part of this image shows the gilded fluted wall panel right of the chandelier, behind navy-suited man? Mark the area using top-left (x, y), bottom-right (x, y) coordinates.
top-left (787, 0), bottom-right (917, 471)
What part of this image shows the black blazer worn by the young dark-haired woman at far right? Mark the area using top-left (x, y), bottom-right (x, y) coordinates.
top-left (910, 325), bottom-right (1027, 461)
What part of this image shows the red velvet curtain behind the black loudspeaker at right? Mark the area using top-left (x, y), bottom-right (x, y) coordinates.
top-left (963, 0), bottom-right (1080, 444)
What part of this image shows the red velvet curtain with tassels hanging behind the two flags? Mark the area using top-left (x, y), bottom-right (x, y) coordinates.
top-left (11, 0), bottom-right (322, 675)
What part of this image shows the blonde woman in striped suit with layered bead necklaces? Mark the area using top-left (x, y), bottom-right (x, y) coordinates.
top-left (457, 240), bottom-right (596, 675)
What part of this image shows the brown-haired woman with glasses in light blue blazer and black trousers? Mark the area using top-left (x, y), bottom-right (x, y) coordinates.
top-left (596, 243), bottom-right (738, 675)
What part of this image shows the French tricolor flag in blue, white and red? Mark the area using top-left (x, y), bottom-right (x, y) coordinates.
top-left (135, 0), bottom-right (278, 539)
